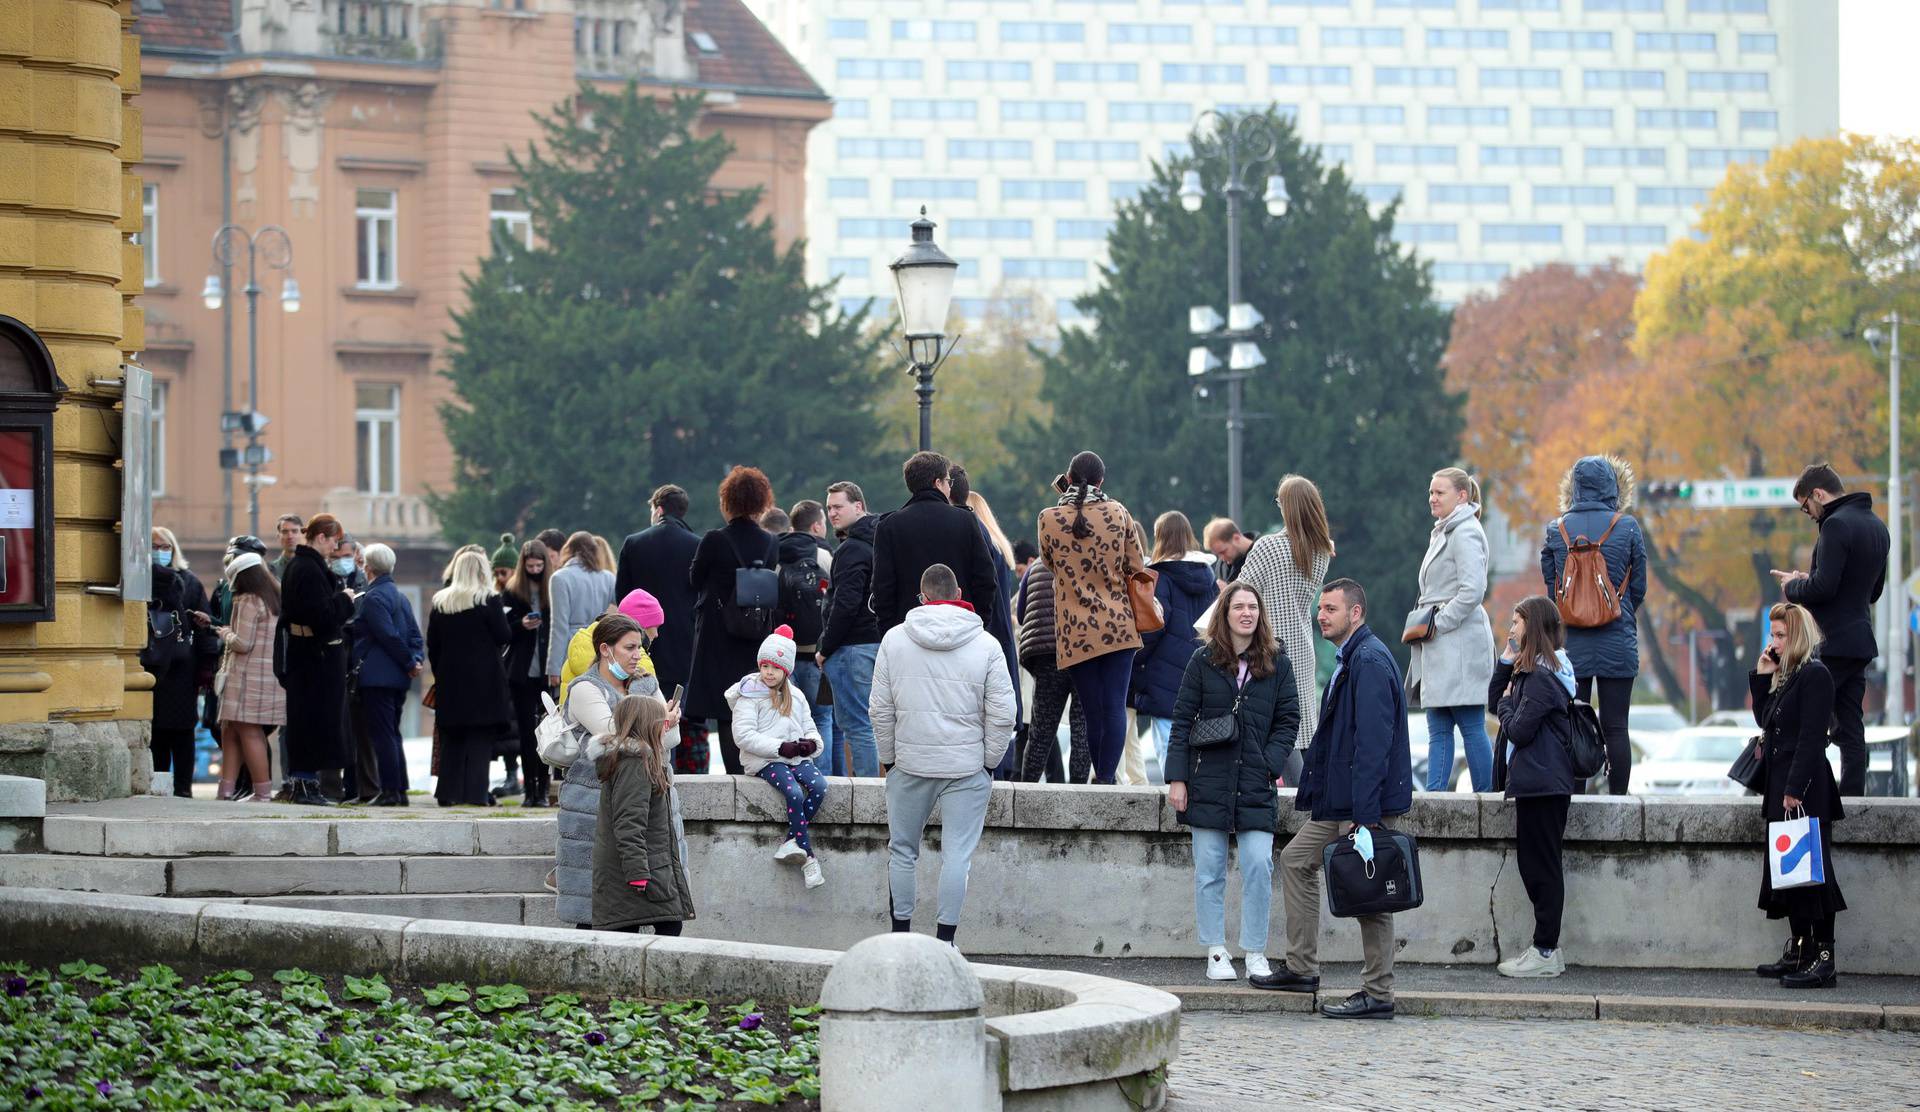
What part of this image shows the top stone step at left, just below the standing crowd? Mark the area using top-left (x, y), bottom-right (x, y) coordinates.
top-left (40, 807), bottom-right (555, 857)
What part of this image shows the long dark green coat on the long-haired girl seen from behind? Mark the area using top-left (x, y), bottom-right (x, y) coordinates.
top-left (593, 757), bottom-right (693, 930)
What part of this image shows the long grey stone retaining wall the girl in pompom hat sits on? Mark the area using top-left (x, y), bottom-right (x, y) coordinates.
top-left (664, 776), bottom-right (1920, 974)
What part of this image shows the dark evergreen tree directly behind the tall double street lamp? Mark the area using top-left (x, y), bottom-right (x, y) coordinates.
top-left (1004, 109), bottom-right (1471, 649)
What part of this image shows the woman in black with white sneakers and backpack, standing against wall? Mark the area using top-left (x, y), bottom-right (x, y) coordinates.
top-left (1486, 595), bottom-right (1574, 978)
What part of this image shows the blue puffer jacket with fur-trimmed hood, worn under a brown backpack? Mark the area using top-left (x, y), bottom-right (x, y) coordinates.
top-left (1540, 455), bottom-right (1647, 678)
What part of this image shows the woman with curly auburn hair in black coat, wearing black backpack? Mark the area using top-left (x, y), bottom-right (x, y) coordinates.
top-left (685, 467), bottom-right (780, 776)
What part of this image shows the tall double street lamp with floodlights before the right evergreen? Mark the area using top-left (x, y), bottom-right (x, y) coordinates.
top-left (1179, 109), bottom-right (1286, 524)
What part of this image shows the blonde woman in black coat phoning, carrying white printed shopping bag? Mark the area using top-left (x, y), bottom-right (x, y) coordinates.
top-left (1747, 603), bottom-right (1847, 989)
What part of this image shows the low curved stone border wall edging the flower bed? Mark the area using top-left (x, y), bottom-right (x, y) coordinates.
top-left (0, 887), bottom-right (1181, 1091)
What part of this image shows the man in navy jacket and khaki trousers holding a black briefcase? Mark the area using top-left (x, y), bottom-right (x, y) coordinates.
top-left (1248, 580), bottom-right (1413, 1020)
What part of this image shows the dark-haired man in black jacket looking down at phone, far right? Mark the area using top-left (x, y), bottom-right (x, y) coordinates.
top-left (1774, 463), bottom-right (1907, 795)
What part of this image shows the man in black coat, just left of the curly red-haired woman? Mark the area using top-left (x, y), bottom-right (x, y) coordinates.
top-left (614, 484), bottom-right (707, 774)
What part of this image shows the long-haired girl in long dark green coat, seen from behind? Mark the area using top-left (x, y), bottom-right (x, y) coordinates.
top-left (593, 695), bottom-right (693, 935)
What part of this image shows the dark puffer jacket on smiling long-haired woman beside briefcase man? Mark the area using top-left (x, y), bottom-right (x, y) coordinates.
top-left (1165, 645), bottom-right (1300, 832)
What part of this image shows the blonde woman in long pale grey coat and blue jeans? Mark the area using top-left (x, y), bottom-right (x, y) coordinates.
top-left (1407, 467), bottom-right (1494, 791)
